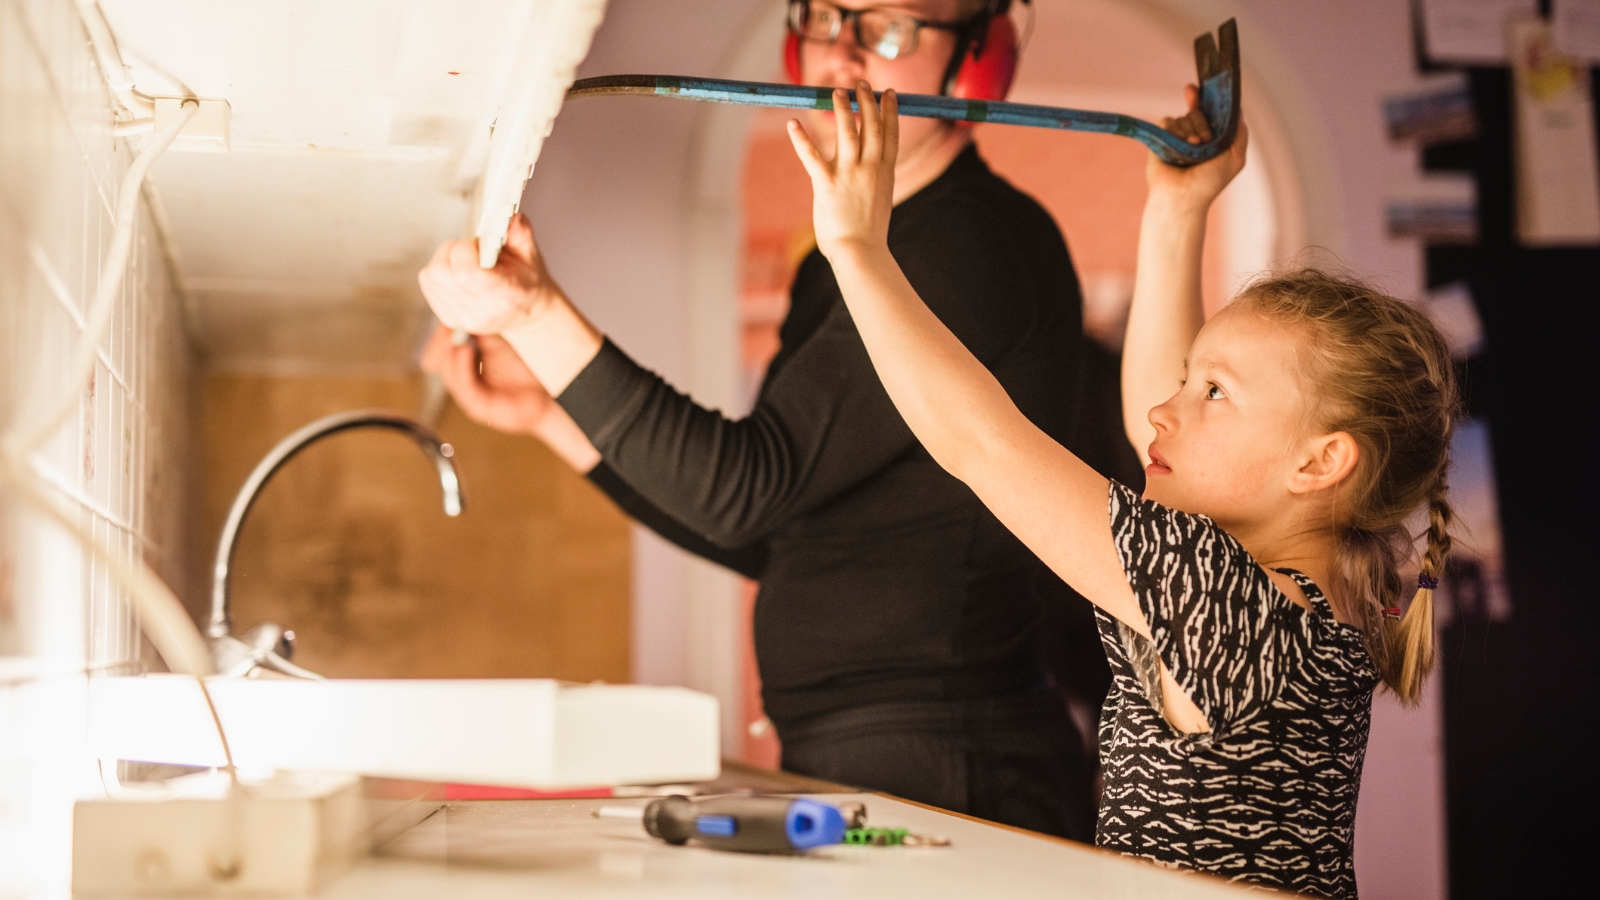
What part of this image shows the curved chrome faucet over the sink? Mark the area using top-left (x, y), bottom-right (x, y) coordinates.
top-left (206, 410), bottom-right (462, 681)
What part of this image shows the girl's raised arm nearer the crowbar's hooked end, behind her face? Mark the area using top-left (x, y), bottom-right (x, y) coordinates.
top-left (1122, 85), bottom-right (1250, 464)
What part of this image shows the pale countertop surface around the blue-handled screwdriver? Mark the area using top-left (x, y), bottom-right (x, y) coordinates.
top-left (331, 794), bottom-right (1243, 900)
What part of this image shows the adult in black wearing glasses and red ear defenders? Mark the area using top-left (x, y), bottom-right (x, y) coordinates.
top-left (419, 0), bottom-right (1096, 841)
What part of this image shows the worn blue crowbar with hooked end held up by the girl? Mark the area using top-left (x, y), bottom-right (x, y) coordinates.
top-left (566, 19), bottom-right (1240, 167)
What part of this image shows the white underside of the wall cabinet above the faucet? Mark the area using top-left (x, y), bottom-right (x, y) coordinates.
top-left (101, 0), bottom-right (605, 373)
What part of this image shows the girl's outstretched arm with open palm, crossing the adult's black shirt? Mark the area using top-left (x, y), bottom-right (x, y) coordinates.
top-left (789, 83), bottom-right (1150, 636)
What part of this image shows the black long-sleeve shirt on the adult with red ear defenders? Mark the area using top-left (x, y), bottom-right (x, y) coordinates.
top-left (558, 147), bottom-right (1082, 725)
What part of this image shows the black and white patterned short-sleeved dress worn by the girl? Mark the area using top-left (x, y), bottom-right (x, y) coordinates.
top-left (1096, 482), bottom-right (1378, 898)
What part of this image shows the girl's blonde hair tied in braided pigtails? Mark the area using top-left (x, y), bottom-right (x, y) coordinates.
top-left (1237, 269), bottom-right (1461, 705)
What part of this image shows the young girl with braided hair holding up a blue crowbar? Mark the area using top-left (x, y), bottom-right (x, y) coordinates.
top-left (790, 83), bottom-right (1456, 897)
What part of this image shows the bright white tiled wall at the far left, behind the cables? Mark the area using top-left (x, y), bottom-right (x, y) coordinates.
top-left (0, 0), bottom-right (189, 897)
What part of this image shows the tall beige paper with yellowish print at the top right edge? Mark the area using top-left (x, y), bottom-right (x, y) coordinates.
top-left (1507, 18), bottom-right (1600, 247)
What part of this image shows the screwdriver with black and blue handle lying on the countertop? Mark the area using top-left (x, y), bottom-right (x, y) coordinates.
top-left (595, 794), bottom-right (845, 854)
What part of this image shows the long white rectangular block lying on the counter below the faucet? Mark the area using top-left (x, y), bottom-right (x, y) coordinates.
top-left (90, 674), bottom-right (722, 788)
